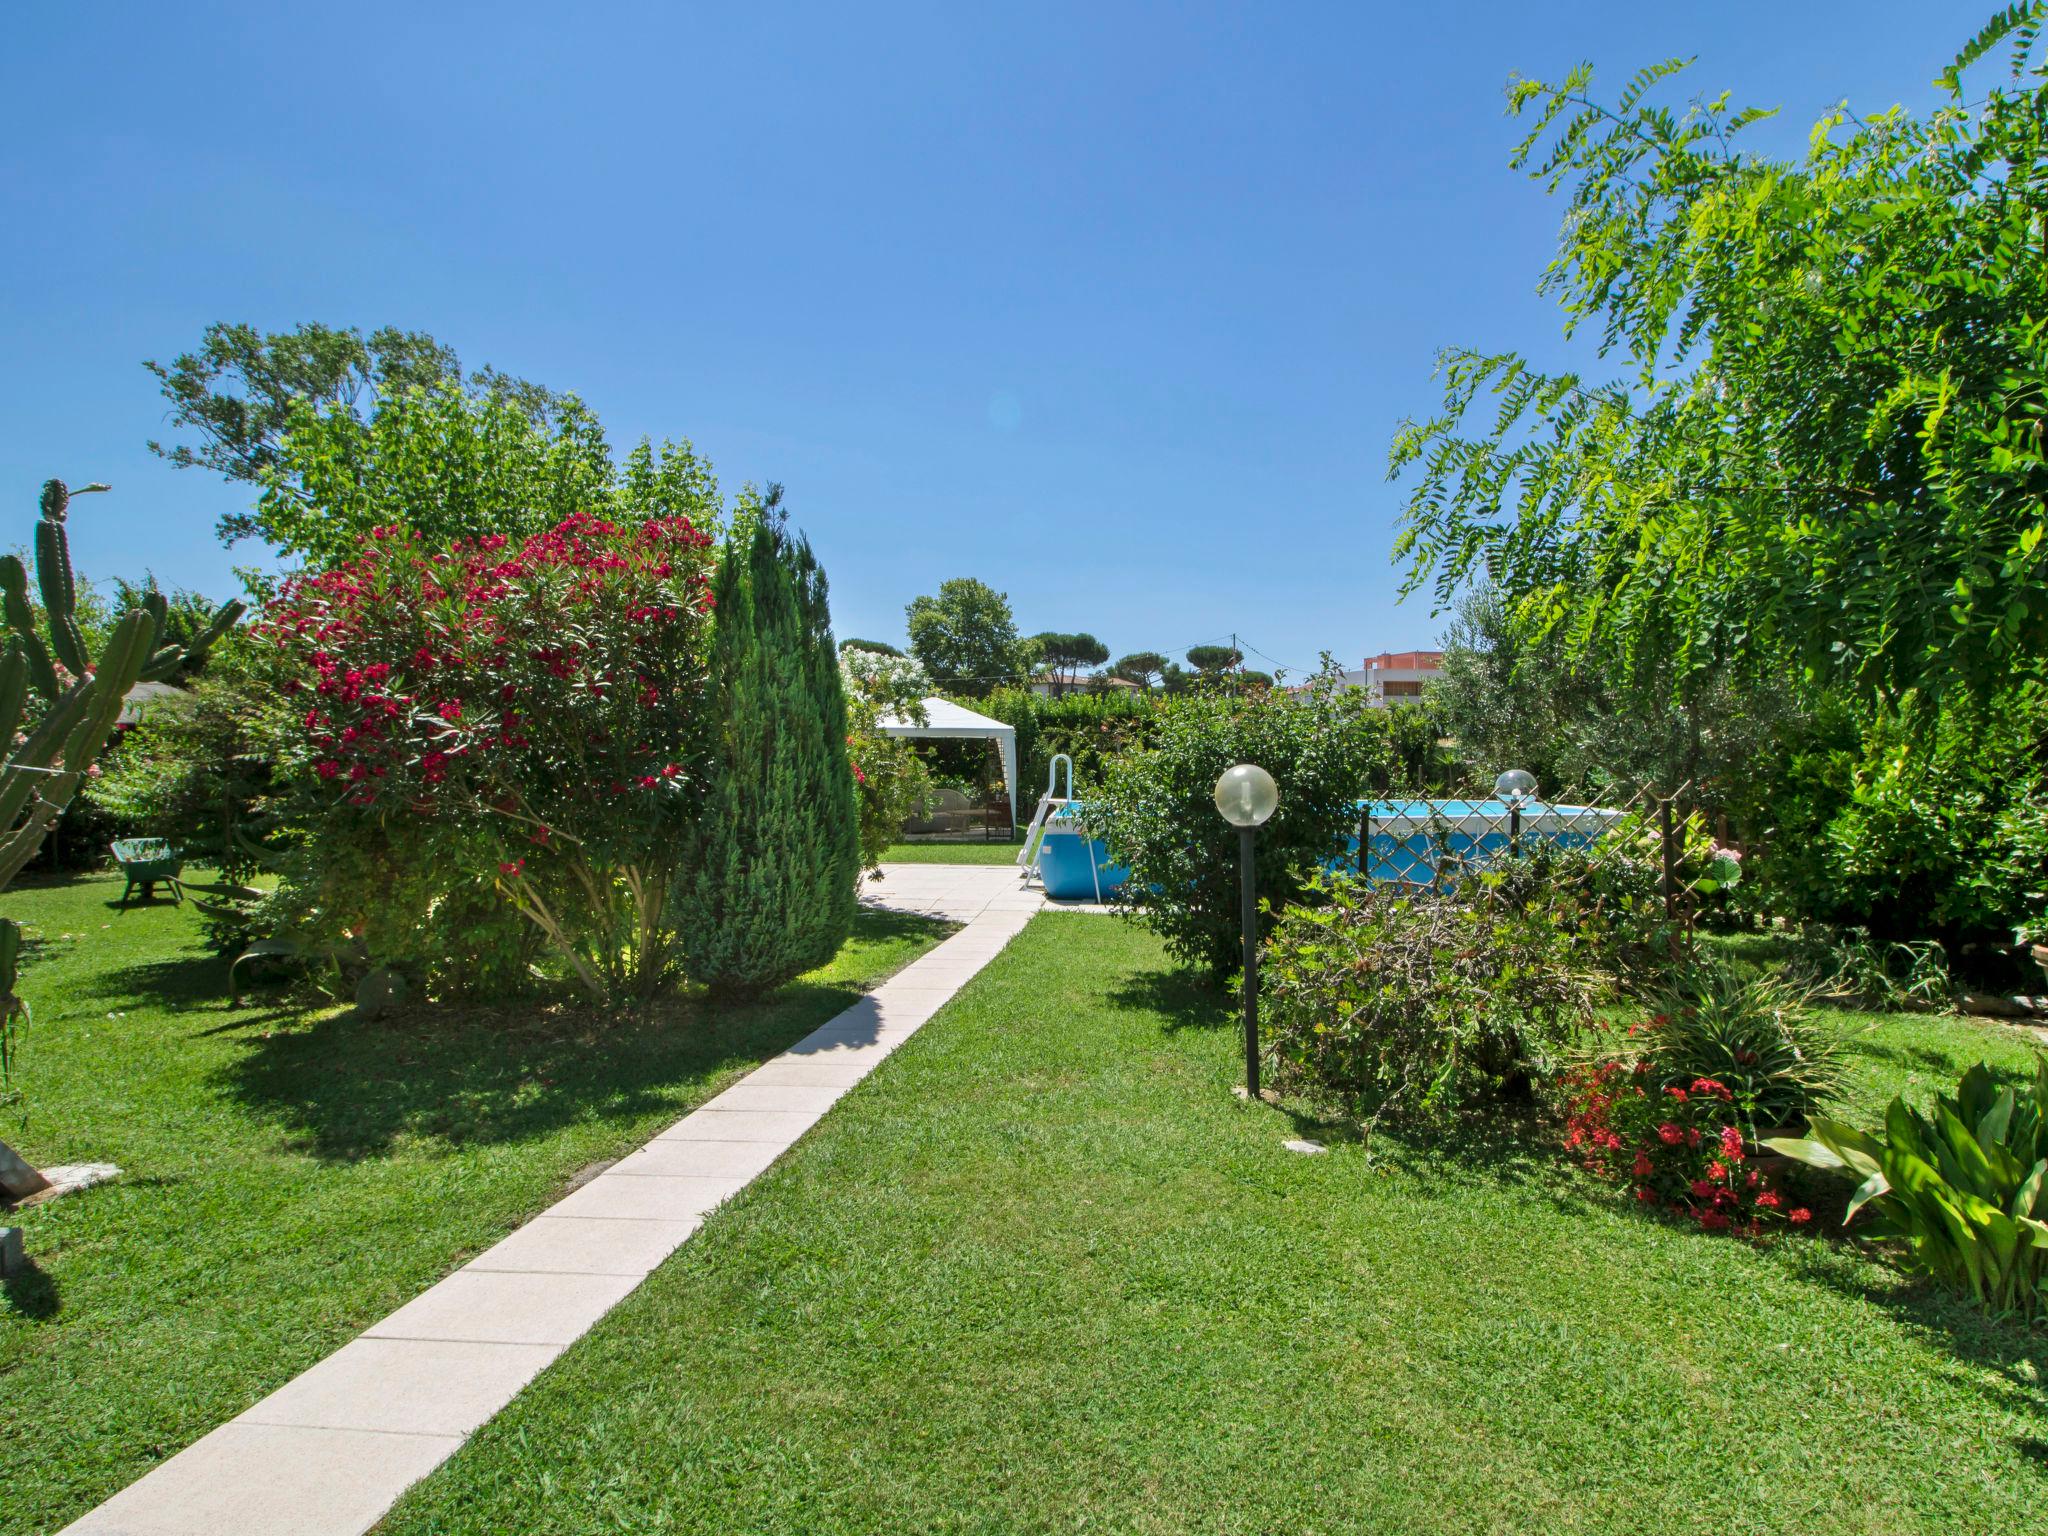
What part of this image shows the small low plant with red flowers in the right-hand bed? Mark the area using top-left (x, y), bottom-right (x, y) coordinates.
top-left (1565, 1059), bottom-right (1812, 1237)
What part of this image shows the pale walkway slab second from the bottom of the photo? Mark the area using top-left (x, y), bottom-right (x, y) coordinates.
top-left (238, 1339), bottom-right (563, 1436)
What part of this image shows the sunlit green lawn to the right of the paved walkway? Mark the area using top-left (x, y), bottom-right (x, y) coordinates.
top-left (385, 915), bottom-right (2048, 1536)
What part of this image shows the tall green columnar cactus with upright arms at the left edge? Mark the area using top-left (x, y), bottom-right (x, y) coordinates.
top-left (0, 479), bottom-right (244, 1198)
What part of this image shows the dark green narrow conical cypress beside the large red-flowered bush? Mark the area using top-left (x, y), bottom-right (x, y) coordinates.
top-left (672, 514), bottom-right (860, 995)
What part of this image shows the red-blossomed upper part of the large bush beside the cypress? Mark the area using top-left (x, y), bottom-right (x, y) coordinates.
top-left (258, 514), bottom-right (711, 813)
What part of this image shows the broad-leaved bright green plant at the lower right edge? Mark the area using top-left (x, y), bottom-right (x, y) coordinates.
top-left (1763, 1057), bottom-right (2048, 1317)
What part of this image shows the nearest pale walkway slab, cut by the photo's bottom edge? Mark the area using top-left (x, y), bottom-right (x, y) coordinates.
top-left (63, 1423), bottom-right (463, 1536)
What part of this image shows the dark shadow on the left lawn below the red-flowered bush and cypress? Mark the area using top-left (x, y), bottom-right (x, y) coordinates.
top-left (219, 911), bottom-right (946, 1161)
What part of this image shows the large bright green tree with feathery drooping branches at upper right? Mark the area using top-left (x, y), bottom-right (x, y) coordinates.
top-left (1393, 12), bottom-right (2048, 720)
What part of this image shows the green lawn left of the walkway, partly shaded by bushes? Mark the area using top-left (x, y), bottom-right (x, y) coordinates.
top-left (0, 877), bottom-right (946, 1536)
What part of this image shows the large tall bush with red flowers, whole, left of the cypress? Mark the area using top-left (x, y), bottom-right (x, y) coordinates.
top-left (258, 514), bottom-right (713, 997)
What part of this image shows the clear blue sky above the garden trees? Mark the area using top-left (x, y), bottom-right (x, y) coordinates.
top-left (0, 0), bottom-right (1966, 668)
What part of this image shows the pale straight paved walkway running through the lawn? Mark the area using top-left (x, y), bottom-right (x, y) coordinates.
top-left (66, 864), bottom-right (1047, 1536)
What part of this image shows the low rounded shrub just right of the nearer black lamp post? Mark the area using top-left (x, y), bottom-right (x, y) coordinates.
top-left (1260, 870), bottom-right (1604, 1122)
